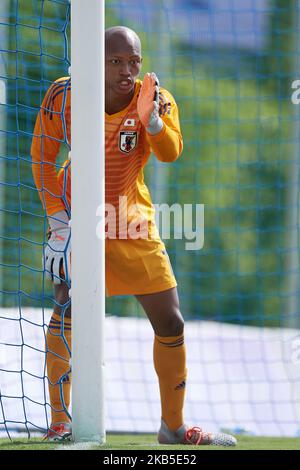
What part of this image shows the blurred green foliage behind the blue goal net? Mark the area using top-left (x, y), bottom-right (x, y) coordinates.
top-left (0, 0), bottom-right (300, 327)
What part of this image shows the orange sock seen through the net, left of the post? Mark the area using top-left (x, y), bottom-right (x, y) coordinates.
top-left (46, 313), bottom-right (71, 423)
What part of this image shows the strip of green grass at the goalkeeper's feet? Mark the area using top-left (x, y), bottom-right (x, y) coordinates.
top-left (0, 434), bottom-right (300, 451)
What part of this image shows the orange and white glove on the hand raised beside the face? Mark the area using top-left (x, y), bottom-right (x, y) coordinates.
top-left (137, 73), bottom-right (164, 135)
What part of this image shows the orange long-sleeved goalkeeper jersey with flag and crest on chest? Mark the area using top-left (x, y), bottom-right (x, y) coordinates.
top-left (31, 77), bottom-right (183, 237)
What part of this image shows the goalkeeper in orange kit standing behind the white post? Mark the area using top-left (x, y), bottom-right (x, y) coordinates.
top-left (31, 26), bottom-right (236, 445)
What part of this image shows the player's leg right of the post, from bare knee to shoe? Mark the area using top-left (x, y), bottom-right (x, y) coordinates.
top-left (136, 288), bottom-right (236, 446)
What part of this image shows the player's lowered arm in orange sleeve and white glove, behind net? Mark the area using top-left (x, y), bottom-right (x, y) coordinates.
top-left (31, 79), bottom-right (70, 284)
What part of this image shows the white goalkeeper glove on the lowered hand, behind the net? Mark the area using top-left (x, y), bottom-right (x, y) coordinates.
top-left (44, 211), bottom-right (71, 284)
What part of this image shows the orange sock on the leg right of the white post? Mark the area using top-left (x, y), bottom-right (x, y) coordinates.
top-left (154, 334), bottom-right (187, 431)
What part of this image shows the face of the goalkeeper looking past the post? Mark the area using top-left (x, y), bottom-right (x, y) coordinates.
top-left (105, 38), bottom-right (142, 95)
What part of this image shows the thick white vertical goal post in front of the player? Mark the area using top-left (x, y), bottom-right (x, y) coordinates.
top-left (71, 0), bottom-right (105, 443)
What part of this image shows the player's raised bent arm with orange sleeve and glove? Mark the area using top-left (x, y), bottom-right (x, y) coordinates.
top-left (137, 73), bottom-right (183, 162)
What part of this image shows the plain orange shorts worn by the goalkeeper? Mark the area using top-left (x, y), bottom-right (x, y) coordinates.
top-left (105, 238), bottom-right (177, 296)
